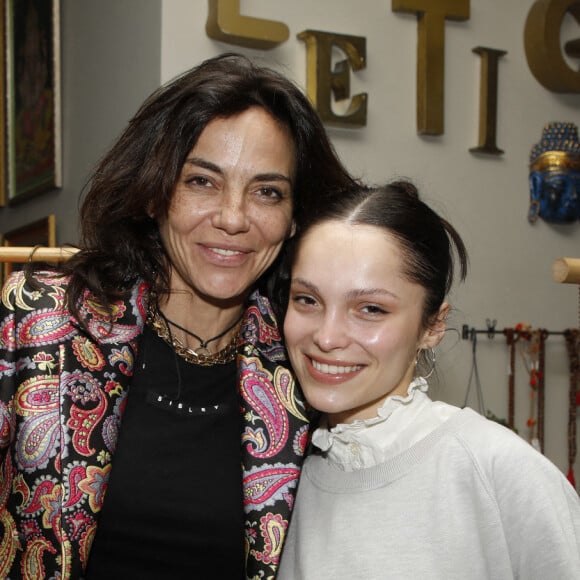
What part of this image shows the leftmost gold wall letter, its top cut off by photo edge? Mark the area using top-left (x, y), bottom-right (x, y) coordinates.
top-left (205, 0), bottom-right (290, 50)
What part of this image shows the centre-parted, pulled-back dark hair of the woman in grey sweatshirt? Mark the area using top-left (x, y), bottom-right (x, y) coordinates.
top-left (272, 180), bottom-right (468, 327)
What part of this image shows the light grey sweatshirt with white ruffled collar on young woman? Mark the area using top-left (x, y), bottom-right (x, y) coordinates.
top-left (277, 380), bottom-right (580, 580)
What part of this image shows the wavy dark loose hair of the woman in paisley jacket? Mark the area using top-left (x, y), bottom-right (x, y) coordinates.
top-left (64, 54), bottom-right (353, 315)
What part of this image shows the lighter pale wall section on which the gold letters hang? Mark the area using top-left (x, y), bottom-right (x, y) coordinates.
top-left (161, 0), bottom-right (580, 474)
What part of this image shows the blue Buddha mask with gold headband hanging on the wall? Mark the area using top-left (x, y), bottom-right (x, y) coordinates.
top-left (528, 123), bottom-right (580, 224)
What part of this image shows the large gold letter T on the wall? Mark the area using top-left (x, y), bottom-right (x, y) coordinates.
top-left (391, 0), bottom-right (469, 135)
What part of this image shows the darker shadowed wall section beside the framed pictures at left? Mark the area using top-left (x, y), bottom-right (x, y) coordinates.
top-left (0, 0), bottom-right (161, 244)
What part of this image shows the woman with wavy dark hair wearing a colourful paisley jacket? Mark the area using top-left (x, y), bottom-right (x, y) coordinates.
top-left (0, 55), bottom-right (352, 579)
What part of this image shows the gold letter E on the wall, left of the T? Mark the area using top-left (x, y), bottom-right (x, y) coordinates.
top-left (297, 30), bottom-right (367, 127)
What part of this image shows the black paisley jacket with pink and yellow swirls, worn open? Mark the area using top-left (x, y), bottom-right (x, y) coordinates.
top-left (0, 272), bottom-right (308, 580)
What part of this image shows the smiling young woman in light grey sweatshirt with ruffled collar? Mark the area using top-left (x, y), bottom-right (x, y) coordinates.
top-left (279, 182), bottom-right (580, 580)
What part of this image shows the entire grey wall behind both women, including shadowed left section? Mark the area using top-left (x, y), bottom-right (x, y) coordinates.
top-left (0, 0), bottom-right (580, 473)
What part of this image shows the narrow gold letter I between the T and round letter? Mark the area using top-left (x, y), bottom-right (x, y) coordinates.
top-left (470, 46), bottom-right (507, 155)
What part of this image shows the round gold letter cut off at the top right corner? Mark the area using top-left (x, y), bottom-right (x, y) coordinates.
top-left (524, 0), bottom-right (580, 93)
